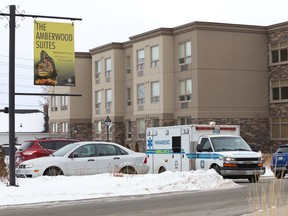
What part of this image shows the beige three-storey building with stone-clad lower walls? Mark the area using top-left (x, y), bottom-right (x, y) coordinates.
top-left (49, 22), bottom-right (288, 151)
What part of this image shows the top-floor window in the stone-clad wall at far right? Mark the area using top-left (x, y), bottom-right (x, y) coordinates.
top-left (270, 41), bottom-right (288, 64)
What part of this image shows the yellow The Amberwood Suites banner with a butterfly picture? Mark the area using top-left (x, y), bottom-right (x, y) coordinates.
top-left (34, 21), bottom-right (75, 86)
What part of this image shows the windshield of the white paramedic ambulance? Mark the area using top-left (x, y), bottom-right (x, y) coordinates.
top-left (211, 137), bottom-right (251, 152)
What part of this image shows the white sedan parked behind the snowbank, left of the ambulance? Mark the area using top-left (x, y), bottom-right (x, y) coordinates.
top-left (15, 141), bottom-right (149, 178)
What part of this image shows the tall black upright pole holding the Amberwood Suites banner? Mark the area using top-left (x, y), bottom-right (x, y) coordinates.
top-left (9, 5), bottom-right (16, 186)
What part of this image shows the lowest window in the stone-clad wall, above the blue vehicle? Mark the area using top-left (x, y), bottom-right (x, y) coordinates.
top-left (271, 117), bottom-right (288, 139)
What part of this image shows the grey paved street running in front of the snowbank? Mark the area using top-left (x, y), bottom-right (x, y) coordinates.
top-left (0, 177), bottom-right (288, 216)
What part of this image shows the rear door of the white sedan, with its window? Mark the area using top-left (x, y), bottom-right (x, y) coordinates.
top-left (97, 144), bottom-right (125, 173)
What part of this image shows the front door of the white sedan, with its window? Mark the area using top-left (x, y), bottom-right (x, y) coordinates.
top-left (66, 144), bottom-right (97, 175)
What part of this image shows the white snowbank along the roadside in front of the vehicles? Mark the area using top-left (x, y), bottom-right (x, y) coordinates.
top-left (0, 168), bottom-right (273, 207)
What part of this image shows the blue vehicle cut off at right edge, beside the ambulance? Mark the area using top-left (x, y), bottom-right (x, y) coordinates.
top-left (270, 144), bottom-right (288, 179)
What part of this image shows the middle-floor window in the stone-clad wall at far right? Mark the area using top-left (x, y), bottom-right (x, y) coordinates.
top-left (271, 80), bottom-right (288, 102)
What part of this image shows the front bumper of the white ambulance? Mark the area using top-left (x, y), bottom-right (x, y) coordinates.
top-left (220, 167), bottom-right (265, 178)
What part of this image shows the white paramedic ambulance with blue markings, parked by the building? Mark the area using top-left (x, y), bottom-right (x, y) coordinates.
top-left (146, 123), bottom-right (265, 182)
